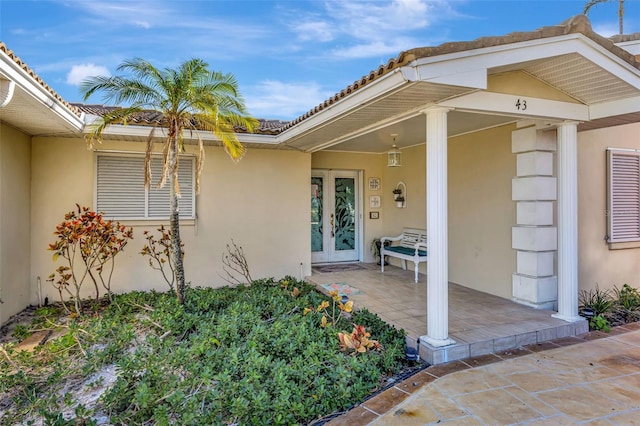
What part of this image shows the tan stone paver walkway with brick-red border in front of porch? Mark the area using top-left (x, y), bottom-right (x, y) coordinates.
top-left (330, 323), bottom-right (640, 426)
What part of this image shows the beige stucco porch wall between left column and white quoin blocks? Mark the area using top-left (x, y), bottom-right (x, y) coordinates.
top-left (449, 126), bottom-right (516, 298)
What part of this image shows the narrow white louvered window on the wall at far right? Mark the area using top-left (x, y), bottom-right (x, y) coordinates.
top-left (607, 150), bottom-right (640, 243)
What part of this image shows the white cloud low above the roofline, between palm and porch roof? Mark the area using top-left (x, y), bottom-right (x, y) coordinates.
top-left (244, 80), bottom-right (332, 120)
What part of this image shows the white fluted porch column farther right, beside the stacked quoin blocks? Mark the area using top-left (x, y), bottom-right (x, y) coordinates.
top-left (554, 122), bottom-right (582, 322)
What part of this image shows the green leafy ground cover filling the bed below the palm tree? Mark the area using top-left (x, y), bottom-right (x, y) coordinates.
top-left (0, 277), bottom-right (406, 425)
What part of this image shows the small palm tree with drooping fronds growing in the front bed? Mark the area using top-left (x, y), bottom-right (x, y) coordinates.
top-left (81, 58), bottom-right (257, 304)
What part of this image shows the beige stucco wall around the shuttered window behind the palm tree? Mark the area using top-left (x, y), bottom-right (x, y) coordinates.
top-left (31, 138), bottom-right (311, 298)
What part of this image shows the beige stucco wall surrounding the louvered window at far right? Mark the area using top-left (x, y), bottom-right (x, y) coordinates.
top-left (578, 123), bottom-right (640, 289)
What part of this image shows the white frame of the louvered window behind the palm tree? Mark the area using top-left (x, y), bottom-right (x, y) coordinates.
top-left (93, 151), bottom-right (196, 221)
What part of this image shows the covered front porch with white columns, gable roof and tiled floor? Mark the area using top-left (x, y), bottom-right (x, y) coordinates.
top-left (298, 16), bottom-right (640, 364)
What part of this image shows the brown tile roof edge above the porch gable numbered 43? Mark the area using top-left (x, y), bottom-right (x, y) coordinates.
top-left (282, 15), bottom-right (640, 130)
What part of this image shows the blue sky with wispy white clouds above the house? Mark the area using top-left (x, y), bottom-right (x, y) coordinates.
top-left (0, 0), bottom-right (640, 120)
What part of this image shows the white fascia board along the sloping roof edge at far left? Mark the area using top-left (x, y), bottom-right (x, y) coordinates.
top-left (0, 54), bottom-right (84, 131)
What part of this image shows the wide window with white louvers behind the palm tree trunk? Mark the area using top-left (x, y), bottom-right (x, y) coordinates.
top-left (95, 153), bottom-right (196, 220)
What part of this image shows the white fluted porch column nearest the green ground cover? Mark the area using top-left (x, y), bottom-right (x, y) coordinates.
top-left (421, 107), bottom-right (454, 347)
